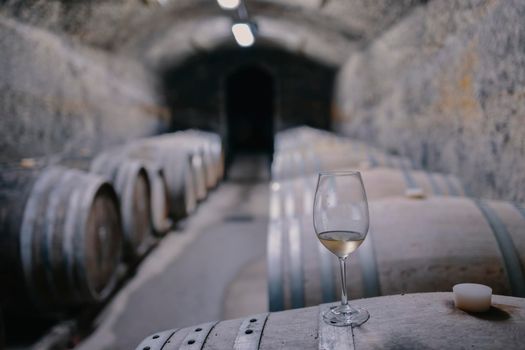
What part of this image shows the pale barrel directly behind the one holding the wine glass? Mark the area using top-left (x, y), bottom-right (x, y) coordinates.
top-left (267, 197), bottom-right (525, 311)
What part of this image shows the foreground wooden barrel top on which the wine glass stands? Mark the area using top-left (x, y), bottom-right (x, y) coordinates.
top-left (136, 293), bottom-right (525, 350)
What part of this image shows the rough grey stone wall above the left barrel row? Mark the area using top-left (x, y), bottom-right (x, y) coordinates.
top-left (0, 17), bottom-right (169, 161)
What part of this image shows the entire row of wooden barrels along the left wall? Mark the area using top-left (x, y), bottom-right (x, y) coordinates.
top-left (0, 130), bottom-right (223, 319)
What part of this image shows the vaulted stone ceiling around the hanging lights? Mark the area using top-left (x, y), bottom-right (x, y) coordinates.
top-left (0, 0), bottom-right (425, 67)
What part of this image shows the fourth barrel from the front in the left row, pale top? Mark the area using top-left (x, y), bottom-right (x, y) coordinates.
top-left (124, 137), bottom-right (198, 220)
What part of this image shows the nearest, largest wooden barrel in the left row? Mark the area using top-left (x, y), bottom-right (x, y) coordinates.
top-left (0, 167), bottom-right (122, 312)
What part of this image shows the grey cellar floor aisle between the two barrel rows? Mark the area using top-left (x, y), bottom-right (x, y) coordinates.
top-left (78, 156), bottom-right (269, 350)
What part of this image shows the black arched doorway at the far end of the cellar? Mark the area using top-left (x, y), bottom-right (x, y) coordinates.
top-left (226, 66), bottom-right (275, 160)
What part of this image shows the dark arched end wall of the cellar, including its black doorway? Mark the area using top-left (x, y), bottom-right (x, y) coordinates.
top-left (160, 42), bottom-right (337, 169)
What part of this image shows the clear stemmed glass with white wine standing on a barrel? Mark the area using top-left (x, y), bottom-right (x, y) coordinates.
top-left (313, 171), bottom-right (370, 327)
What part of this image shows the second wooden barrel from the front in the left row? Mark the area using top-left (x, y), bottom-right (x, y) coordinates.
top-left (90, 151), bottom-right (154, 262)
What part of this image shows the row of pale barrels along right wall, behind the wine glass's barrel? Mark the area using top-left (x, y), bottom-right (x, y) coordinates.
top-left (267, 127), bottom-right (525, 311)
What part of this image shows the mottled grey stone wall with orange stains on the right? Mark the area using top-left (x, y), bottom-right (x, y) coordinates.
top-left (335, 0), bottom-right (525, 202)
